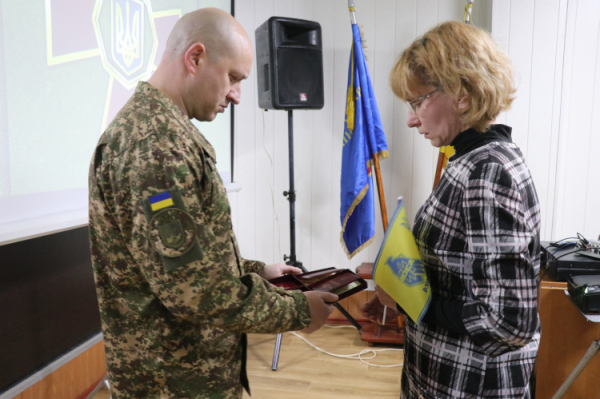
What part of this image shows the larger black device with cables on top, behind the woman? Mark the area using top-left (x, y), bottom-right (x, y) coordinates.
top-left (541, 241), bottom-right (600, 281)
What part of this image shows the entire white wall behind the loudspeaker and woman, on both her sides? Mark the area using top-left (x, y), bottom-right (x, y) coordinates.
top-left (230, 0), bottom-right (600, 269)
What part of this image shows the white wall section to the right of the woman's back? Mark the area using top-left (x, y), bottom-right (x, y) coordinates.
top-left (492, 0), bottom-right (600, 244)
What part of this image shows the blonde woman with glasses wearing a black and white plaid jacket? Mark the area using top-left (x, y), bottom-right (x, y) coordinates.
top-left (363, 22), bottom-right (541, 398)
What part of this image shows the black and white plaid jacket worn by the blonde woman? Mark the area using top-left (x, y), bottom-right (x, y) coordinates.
top-left (402, 125), bottom-right (541, 399)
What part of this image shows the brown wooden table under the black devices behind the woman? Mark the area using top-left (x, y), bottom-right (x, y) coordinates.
top-left (536, 277), bottom-right (600, 399)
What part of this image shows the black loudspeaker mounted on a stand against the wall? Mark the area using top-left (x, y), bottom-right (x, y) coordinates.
top-left (255, 17), bottom-right (325, 109)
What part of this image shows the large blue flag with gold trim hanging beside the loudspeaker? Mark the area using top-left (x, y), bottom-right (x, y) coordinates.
top-left (340, 24), bottom-right (388, 258)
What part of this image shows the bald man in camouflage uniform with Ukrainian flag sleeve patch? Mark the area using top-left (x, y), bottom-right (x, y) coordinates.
top-left (89, 9), bottom-right (337, 398)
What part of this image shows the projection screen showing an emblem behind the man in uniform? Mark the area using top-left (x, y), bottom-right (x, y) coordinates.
top-left (0, 0), bottom-right (231, 245)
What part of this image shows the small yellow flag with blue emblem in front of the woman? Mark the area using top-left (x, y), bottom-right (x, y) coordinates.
top-left (373, 197), bottom-right (431, 324)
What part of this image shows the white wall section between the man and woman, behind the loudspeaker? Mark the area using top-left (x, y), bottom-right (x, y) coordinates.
top-left (230, 0), bottom-right (491, 269)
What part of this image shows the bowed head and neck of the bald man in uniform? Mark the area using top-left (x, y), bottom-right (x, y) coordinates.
top-left (148, 8), bottom-right (254, 121)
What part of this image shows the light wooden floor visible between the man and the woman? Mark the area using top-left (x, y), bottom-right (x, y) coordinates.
top-left (94, 325), bottom-right (403, 399)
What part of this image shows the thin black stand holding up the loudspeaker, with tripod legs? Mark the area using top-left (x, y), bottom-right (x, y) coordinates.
top-left (271, 109), bottom-right (362, 371)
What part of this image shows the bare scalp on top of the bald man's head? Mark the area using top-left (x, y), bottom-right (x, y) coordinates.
top-left (163, 8), bottom-right (251, 62)
